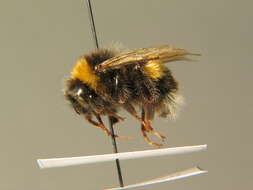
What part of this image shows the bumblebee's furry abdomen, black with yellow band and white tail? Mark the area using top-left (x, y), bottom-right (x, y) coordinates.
top-left (124, 66), bottom-right (183, 118)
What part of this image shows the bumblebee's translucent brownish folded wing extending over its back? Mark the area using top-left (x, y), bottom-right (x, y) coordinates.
top-left (95, 45), bottom-right (199, 72)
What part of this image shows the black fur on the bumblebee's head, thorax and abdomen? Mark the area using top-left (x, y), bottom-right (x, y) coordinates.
top-left (65, 49), bottom-right (178, 119)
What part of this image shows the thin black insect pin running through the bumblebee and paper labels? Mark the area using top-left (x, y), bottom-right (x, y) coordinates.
top-left (86, 0), bottom-right (124, 187)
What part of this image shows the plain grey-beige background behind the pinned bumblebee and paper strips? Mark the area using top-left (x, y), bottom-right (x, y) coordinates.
top-left (0, 0), bottom-right (253, 190)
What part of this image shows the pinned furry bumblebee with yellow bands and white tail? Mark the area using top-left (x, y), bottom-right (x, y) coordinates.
top-left (64, 45), bottom-right (198, 146)
